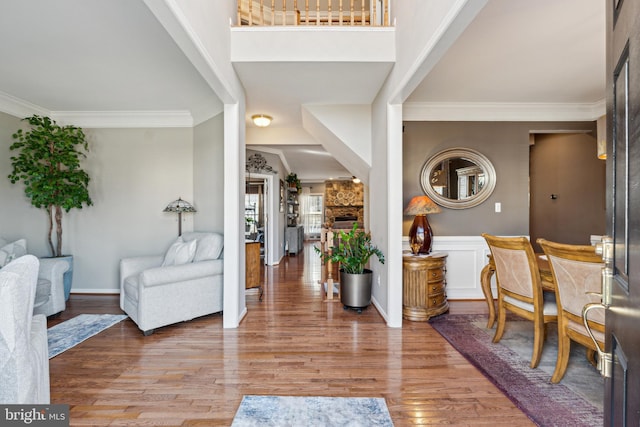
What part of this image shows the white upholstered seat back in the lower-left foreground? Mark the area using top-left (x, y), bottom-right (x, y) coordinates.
top-left (0, 255), bottom-right (50, 404)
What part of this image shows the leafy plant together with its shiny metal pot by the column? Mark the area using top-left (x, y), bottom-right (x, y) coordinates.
top-left (315, 223), bottom-right (384, 313)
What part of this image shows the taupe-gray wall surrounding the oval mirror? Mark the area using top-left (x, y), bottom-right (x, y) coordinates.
top-left (402, 122), bottom-right (594, 236)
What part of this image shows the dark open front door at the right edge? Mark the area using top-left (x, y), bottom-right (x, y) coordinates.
top-left (604, 0), bottom-right (640, 426)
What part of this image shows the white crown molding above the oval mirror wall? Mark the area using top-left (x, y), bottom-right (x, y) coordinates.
top-left (402, 99), bottom-right (606, 122)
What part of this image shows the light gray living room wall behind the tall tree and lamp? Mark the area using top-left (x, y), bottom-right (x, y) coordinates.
top-left (0, 113), bottom-right (223, 293)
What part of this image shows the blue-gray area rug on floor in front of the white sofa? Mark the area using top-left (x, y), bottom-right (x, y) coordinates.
top-left (47, 314), bottom-right (127, 359)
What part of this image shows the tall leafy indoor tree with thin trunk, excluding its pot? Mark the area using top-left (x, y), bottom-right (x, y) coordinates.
top-left (8, 115), bottom-right (93, 256)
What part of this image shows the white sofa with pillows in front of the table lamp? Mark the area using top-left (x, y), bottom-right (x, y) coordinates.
top-left (120, 232), bottom-right (224, 335)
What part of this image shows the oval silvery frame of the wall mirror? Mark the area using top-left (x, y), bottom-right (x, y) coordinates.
top-left (420, 147), bottom-right (497, 209)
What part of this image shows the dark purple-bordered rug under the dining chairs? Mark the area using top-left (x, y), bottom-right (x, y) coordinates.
top-left (429, 314), bottom-right (603, 427)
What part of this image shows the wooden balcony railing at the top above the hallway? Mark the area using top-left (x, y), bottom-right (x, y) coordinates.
top-left (237, 0), bottom-right (389, 27)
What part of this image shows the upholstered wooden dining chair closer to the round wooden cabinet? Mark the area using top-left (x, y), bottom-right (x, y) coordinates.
top-left (482, 233), bottom-right (558, 368)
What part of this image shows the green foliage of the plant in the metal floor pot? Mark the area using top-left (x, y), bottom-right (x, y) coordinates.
top-left (315, 223), bottom-right (384, 274)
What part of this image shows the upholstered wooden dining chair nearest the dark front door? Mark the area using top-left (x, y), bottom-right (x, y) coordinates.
top-left (537, 239), bottom-right (605, 383)
